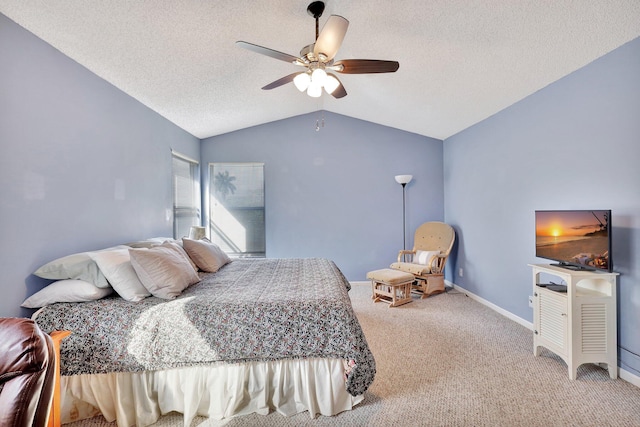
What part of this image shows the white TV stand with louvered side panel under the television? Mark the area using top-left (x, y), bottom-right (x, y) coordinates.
top-left (529, 264), bottom-right (618, 380)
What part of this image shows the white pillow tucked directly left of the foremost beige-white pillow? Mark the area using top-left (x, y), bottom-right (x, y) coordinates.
top-left (91, 247), bottom-right (151, 302)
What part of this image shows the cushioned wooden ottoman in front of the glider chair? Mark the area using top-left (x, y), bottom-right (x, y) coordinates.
top-left (367, 268), bottom-right (415, 308)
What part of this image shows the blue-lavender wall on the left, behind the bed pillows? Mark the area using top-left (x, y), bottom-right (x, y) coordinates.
top-left (0, 14), bottom-right (200, 316)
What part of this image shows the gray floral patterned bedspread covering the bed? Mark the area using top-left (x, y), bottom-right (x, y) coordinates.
top-left (36, 258), bottom-right (375, 396)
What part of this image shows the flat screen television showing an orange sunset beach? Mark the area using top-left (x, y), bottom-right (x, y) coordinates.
top-left (535, 210), bottom-right (613, 272)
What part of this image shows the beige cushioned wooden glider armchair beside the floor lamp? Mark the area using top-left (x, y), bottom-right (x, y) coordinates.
top-left (391, 221), bottom-right (456, 298)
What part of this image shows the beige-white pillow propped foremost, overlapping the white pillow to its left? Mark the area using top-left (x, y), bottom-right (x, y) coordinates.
top-left (129, 246), bottom-right (200, 299)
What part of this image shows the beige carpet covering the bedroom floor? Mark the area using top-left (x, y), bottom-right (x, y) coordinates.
top-left (69, 284), bottom-right (640, 427)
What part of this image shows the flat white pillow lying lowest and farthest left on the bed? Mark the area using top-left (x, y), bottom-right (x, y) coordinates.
top-left (22, 279), bottom-right (113, 308)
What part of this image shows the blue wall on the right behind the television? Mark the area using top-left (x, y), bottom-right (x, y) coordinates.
top-left (444, 39), bottom-right (640, 375)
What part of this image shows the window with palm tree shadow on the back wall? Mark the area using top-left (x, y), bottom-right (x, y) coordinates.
top-left (209, 163), bottom-right (266, 257)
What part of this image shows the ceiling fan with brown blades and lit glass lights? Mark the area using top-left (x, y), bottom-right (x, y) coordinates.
top-left (236, 1), bottom-right (400, 98)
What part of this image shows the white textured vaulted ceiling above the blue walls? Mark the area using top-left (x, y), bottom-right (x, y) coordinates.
top-left (0, 0), bottom-right (640, 139)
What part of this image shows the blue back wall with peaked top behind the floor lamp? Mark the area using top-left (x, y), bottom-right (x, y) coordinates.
top-left (201, 112), bottom-right (444, 280)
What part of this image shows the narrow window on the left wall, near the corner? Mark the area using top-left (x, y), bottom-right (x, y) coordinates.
top-left (171, 151), bottom-right (200, 239)
